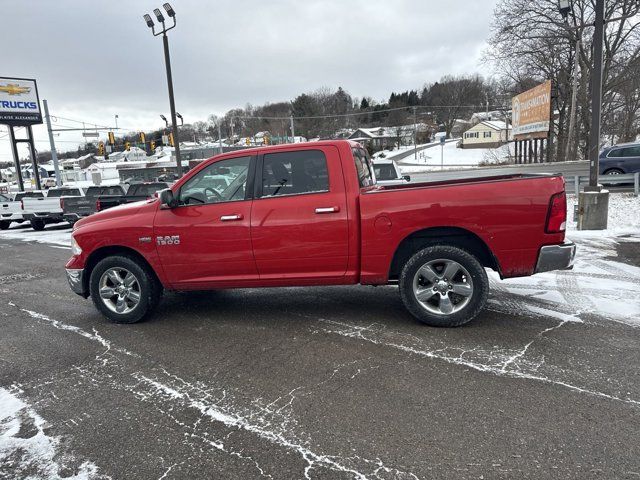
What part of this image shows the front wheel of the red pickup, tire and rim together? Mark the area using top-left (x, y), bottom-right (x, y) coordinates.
top-left (89, 255), bottom-right (162, 323)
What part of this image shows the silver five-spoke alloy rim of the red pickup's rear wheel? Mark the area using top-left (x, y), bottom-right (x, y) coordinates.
top-left (413, 259), bottom-right (473, 316)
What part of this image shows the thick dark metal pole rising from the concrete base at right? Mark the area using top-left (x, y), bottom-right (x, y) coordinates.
top-left (585, 0), bottom-right (605, 192)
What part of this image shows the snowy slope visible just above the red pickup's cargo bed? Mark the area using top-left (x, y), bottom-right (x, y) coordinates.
top-left (399, 142), bottom-right (514, 173)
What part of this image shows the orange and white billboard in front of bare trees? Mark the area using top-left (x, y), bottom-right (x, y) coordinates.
top-left (511, 80), bottom-right (551, 140)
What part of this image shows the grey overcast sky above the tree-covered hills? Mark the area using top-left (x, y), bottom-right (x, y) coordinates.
top-left (0, 0), bottom-right (497, 161)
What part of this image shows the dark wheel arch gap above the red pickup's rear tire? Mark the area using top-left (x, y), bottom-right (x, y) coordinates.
top-left (389, 227), bottom-right (500, 280)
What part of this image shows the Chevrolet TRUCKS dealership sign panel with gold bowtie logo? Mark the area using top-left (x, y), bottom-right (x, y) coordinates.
top-left (0, 77), bottom-right (42, 126)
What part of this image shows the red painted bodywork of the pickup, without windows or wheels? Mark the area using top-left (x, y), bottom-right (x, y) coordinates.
top-left (67, 141), bottom-right (566, 290)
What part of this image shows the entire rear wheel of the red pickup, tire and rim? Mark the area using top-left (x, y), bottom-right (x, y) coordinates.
top-left (400, 246), bottom-right (489, 327)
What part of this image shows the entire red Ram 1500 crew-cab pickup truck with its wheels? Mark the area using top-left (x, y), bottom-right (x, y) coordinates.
top-left (66, 140), bottom-right (575, 326)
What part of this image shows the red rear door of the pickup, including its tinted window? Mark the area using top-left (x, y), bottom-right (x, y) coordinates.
top-left (251, 146), bottom-right (349, 285)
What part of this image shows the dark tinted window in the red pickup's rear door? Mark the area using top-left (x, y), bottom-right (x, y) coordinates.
top-left (262, 150), bottom-right (329, 197)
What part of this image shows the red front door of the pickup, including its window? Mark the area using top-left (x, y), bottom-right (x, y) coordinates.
top-left (153, 156), bottom-right (258, 289)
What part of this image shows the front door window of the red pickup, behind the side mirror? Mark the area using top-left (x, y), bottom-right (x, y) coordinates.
top-left (179, 157), bottom-right (251, 205)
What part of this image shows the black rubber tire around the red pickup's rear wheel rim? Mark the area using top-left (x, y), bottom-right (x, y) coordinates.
top-left (400, 245), bottom-right (489, 327)
